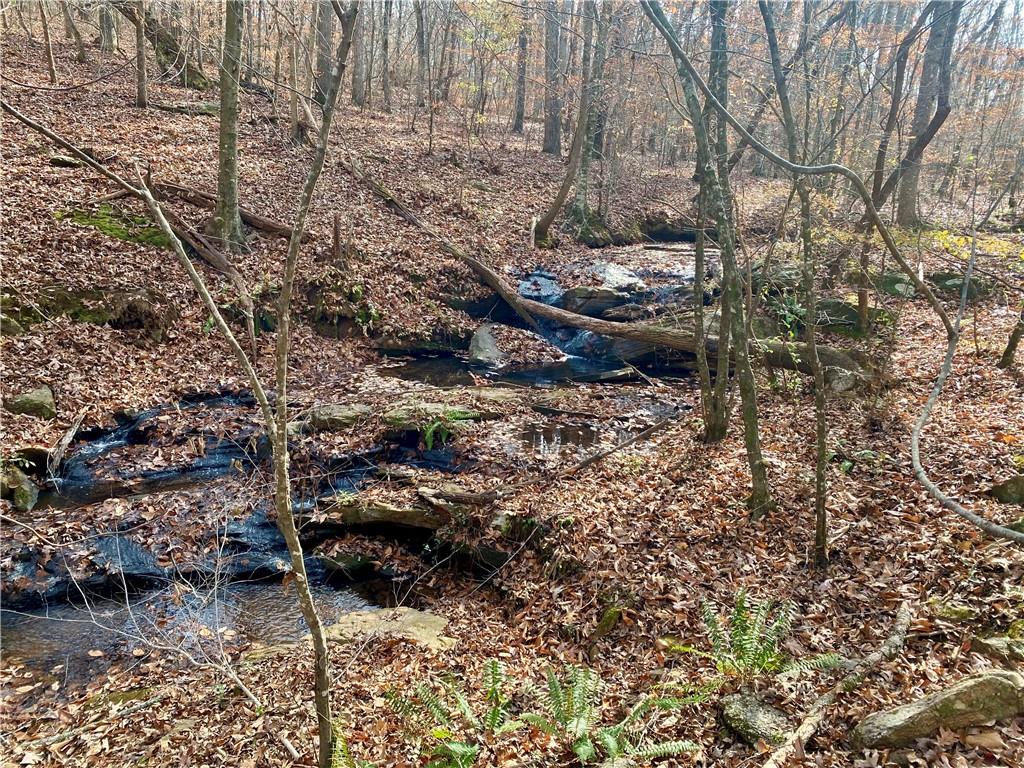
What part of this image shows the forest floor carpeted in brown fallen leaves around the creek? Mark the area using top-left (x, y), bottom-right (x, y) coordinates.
top-left (6, 36), bottom-right (1024, 766)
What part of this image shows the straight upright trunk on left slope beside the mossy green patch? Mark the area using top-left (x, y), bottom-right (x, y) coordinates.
top-left (211, 0), bottom-right (245, 251)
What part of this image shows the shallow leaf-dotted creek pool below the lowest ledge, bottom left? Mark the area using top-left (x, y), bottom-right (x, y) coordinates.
top-left (0, 582), bottom-right (375, 681)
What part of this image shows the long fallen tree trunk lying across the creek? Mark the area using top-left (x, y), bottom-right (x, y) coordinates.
top-left (338, 158), bottom-right (869, 392)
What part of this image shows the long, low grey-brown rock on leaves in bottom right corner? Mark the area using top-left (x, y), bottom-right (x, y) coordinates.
top-left (852, 670), bottom-right (1024, 749)
